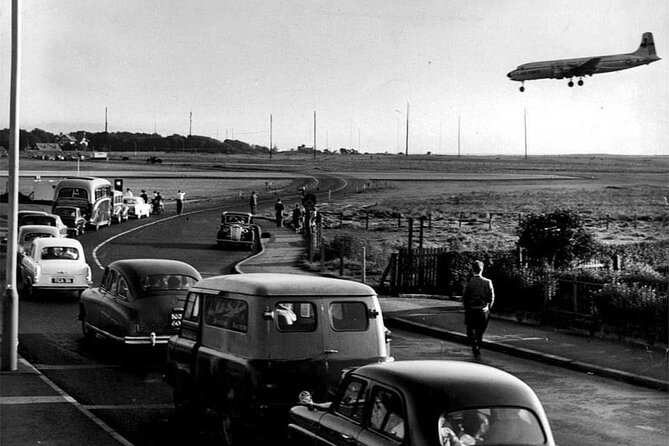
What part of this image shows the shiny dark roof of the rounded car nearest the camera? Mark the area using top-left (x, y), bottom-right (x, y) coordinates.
top-left (352, 360), bottom-right (540, 410)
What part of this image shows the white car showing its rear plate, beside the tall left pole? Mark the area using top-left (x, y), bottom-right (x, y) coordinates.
top-left (19, 237), bottom-right (91, 297)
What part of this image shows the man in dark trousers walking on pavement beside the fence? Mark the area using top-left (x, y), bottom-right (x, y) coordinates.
top-left (462, 260), bottom-right (495, 357)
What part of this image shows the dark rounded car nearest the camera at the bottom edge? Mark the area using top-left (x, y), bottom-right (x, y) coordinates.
top-left (288, 360), bottom-right (555, 446)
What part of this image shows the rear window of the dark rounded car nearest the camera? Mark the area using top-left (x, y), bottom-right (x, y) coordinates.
top-left (436, 407), bottom-right (546, 446)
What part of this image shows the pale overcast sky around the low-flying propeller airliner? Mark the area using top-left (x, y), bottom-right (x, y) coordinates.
top-left (0, 0), bottom-right (669, 155)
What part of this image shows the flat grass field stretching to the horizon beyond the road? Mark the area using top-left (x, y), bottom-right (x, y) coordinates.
top-left (0, 152), bottom-right (669, 256)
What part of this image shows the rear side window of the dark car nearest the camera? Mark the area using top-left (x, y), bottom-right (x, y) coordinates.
top-left (367, 386), bottom-right (406, 440)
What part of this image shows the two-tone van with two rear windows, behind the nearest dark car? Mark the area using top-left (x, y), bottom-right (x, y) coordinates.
top-left (165, 273), bottom-right (392, 445)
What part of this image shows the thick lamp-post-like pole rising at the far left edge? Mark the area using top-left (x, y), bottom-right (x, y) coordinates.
top-left (0, 0), bottom-right (21, 371)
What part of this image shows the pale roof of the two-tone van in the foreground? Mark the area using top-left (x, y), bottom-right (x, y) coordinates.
top-left (194, 273), bottom-right (376, 297)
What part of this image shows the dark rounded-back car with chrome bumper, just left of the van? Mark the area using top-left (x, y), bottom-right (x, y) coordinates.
top-left (79, 259), bottom-right (202, 346)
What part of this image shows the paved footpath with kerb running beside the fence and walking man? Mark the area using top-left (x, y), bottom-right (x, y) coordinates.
top-left (236, 228), bottom-right (669, 392)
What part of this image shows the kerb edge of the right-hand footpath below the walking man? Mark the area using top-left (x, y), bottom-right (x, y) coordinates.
top-left (384, 317), bottom-right (669, 392)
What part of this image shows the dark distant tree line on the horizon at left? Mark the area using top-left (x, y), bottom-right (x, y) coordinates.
top-left (0, 129), bottom-right (269, 154)
